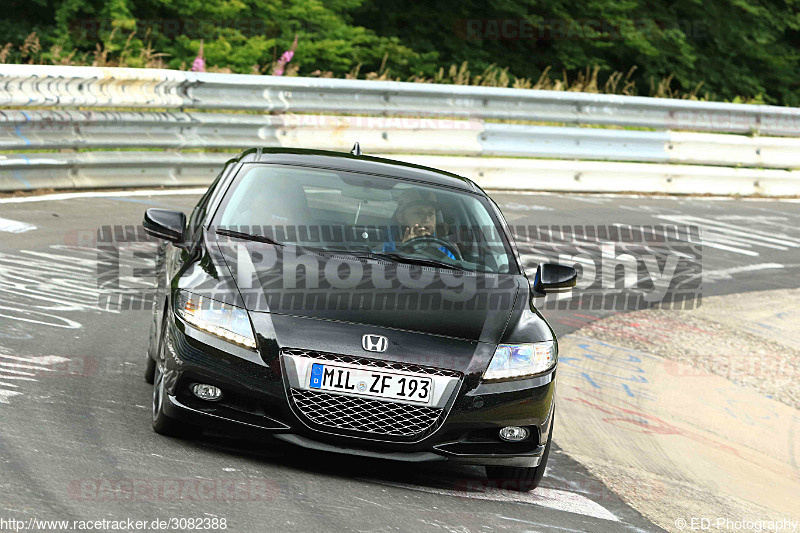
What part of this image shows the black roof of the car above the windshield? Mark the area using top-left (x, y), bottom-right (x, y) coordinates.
top-left (231, 148), bottom-right (485, 195)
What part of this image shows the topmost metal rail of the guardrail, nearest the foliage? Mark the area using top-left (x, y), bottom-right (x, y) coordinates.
top-left (0, 65), bottom-right (800, 136)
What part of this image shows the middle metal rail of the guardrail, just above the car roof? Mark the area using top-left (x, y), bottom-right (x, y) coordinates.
top-left (6, 110), bottom-right (800, 169)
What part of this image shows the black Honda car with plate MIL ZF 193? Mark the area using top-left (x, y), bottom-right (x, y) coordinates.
top-left (144, 149), bottom-right (576, 490)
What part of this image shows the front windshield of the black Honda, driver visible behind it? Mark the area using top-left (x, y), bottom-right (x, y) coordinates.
top-left (214, 164), bottom-right (518, 274)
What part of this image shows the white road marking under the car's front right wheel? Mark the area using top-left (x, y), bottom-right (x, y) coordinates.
top-left (372, 479), bottom-right (619, 522)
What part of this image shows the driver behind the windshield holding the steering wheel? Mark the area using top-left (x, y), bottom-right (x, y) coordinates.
top-left (383, 189), bottom-right (456, 259)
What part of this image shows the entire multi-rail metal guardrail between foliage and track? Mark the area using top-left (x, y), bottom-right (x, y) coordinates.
top-left (0, 65), bottom-right (800, 195)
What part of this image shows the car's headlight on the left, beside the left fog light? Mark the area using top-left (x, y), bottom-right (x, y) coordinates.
top-left (175, 291), bottom-right (256, 350)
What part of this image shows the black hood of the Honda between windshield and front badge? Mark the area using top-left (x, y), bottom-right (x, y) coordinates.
top-left (212, 234), bottom-right (529, 343)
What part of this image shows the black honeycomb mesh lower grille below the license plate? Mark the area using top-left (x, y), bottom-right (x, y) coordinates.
top-left (290, 389), bottom-right (442, 439)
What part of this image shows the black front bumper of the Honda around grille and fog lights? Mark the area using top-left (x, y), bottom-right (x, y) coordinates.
top-left (163, 317), bottom-right (556, 467)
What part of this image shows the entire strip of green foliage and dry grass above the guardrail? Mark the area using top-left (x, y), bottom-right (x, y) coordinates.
top-left (0, 0), bottom-right (800, 106)
